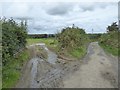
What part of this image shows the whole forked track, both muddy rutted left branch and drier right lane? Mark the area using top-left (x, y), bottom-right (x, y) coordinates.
top-left (16, 42), bottom-right (118, 88)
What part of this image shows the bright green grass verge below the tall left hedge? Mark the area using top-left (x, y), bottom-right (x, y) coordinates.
top-left (2, 49), bottom-right (30, 88)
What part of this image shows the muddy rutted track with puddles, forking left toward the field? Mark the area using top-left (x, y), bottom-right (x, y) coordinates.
top-left (16, 43), bottom-right (79, 88)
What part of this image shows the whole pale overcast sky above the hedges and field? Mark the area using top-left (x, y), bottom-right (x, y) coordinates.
top-left (0, 0), bottom-right (118, 34)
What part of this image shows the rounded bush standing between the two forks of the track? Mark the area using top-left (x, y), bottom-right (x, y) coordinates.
top-left (57, 27), bottom-right (88, 48)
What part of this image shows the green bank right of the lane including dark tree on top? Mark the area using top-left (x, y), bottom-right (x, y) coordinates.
top-left (100, 23), bottom-right (120, 56)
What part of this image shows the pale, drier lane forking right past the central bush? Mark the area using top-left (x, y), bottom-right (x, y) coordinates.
top-left (64, 42), bottom-right (118, 88)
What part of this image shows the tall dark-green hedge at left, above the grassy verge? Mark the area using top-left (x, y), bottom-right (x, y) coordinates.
top-left (1, 19), bottom-right (27, 65)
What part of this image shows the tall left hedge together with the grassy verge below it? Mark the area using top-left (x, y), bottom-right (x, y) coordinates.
top-left (0, 19), bottom-right (29, 88)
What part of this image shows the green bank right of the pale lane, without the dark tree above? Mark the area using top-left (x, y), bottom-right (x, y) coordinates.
top-left (99, 32), bottom-right (120, 56)
